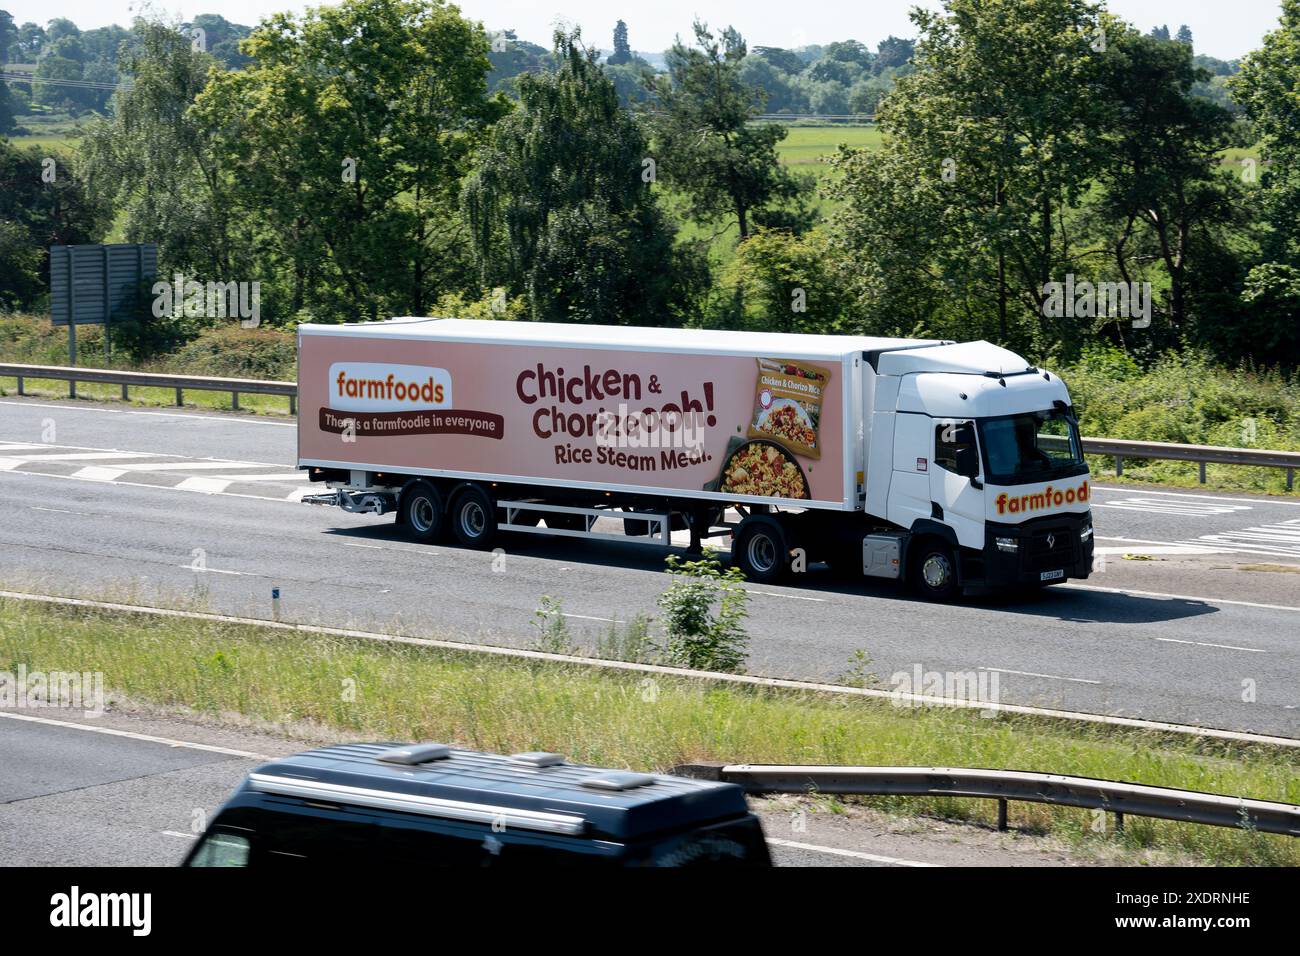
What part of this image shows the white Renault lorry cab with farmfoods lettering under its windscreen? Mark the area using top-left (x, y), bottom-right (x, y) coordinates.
top-left (863, 342), bottom-right (1092, 597)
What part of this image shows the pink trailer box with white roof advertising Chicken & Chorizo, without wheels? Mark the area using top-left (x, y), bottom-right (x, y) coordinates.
top-left (298, 319), bottom-right (861, 510)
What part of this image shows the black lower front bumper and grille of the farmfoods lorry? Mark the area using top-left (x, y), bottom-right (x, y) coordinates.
top-left (962, 512), bottom-right (1093, 588)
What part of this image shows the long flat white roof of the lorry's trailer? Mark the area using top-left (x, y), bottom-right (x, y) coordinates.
top-left (298, 317), bottom-right (939, 359)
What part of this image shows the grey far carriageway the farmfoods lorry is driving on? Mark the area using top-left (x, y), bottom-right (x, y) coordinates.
top-left (0, 399), bottom-right (1300, 736)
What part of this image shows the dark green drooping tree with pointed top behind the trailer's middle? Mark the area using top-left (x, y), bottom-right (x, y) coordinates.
top-left (463, 31), bottom-right (693, 325)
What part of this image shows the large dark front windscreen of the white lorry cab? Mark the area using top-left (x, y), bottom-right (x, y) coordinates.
top-left (979, 410), bottom-right (1087, 485)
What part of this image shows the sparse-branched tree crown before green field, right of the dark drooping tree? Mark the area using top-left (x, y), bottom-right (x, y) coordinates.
top-left (653, 21), bottom-right (809, 239)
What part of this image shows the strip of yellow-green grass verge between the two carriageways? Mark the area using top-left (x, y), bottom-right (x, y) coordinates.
top-left (0, 600), bottom-right (1300, 866)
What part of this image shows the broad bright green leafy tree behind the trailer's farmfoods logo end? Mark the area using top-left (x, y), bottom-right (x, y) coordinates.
top-left (192, 0), bottom-right (506, 319)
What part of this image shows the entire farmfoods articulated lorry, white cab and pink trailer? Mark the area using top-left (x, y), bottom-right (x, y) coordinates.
top-left (298, 325), bottom-right (1093, 600)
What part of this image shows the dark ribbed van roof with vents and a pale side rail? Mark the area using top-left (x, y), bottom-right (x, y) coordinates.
top-left (242, 744), bottom-right (749, 840)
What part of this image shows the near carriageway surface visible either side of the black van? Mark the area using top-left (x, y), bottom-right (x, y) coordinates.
top-left (0, 710), bottom-right (1096, 866)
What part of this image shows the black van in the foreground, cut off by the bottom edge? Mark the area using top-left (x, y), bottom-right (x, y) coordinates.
top-left (182, 744), bottom-right (772, 866)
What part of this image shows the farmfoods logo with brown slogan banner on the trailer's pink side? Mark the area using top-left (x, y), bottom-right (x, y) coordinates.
top-left (320, 362), bottom-right (506, 438)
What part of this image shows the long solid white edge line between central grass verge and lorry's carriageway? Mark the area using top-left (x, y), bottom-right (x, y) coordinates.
top-left (10, 591), bottom-right (1300, 748)
